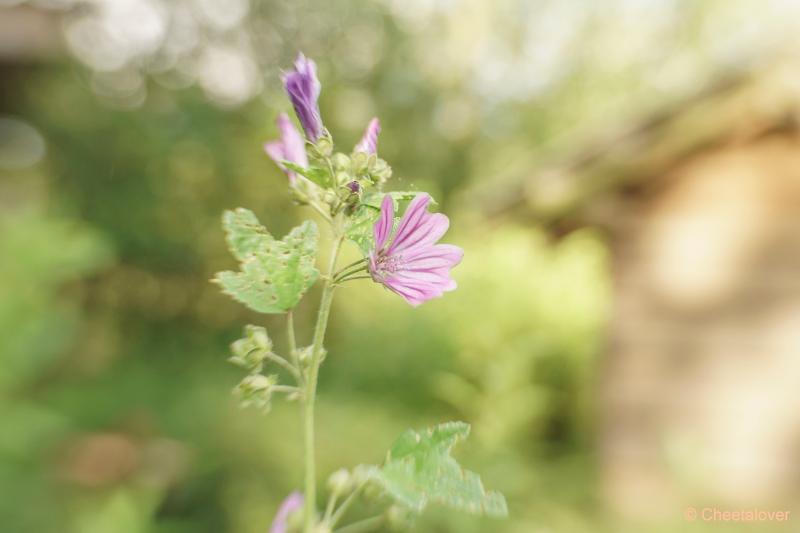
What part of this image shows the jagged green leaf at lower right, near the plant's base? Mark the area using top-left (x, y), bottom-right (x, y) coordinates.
top-left (369, 422), bottom-right (508, 517)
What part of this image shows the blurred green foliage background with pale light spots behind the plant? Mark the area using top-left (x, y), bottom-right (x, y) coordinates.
top-left (0, 0), bottom-right (800, 533)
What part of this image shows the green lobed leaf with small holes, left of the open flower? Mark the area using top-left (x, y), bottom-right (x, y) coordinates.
top-left (214, 208), bottom-right (319, 313)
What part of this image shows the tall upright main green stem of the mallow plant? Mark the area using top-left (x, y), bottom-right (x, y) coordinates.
top-left (303, 231), bottom-right (344, 533)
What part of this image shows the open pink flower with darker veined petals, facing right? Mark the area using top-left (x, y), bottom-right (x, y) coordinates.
top-left (369, 193), bottom-right (464, 307)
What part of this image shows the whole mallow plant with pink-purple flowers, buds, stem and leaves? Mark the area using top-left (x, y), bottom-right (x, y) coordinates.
top-left (214, 54), bottom-right (507, 533)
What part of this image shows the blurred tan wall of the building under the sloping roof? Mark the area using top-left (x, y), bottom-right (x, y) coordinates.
top-left (601, 123), bottom-right (800, 518)
